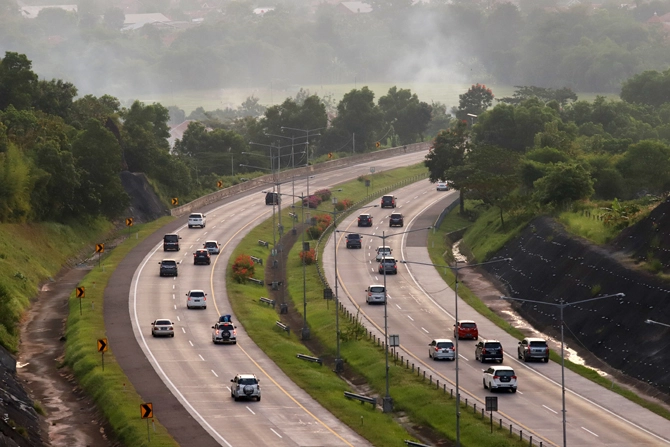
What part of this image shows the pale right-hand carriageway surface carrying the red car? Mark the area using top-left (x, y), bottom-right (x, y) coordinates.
top-left (324, 182), bottom-right (670, 446)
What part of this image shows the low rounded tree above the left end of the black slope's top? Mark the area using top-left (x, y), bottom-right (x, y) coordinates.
top-left (534, 163), bottom-right (593, 206)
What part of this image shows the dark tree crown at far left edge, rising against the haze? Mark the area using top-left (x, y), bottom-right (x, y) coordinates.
top-left (0, 51), bottom-right (37, 110)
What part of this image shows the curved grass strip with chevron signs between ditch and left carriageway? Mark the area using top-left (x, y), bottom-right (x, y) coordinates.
top-left (65, 217), bottom-right (178, 447)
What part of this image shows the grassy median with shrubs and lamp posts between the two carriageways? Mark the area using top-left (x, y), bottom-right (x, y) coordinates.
top-left (228, 166), bottom-right (540, 447)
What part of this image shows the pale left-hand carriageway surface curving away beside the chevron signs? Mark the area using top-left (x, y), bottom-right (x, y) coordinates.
top-left (129, 153), bottom-right (425, 447)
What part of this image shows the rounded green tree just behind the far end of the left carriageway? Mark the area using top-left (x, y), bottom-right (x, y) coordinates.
top-left (379, 86), bottom-right (432, 144)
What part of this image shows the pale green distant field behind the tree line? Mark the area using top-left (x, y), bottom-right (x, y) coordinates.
top-left (126, 82), bottom-right (618, 114)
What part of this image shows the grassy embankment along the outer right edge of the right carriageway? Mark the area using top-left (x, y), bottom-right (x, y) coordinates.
top-left (428, 201), bottom-right (670, 419)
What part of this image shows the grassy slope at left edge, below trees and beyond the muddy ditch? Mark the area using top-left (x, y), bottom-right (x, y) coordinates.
top-left (0, 220), bottom-right (111, 352)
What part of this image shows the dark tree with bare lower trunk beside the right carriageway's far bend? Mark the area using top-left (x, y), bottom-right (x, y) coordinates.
top-left (424, 121), bottom-right (470, 214)
